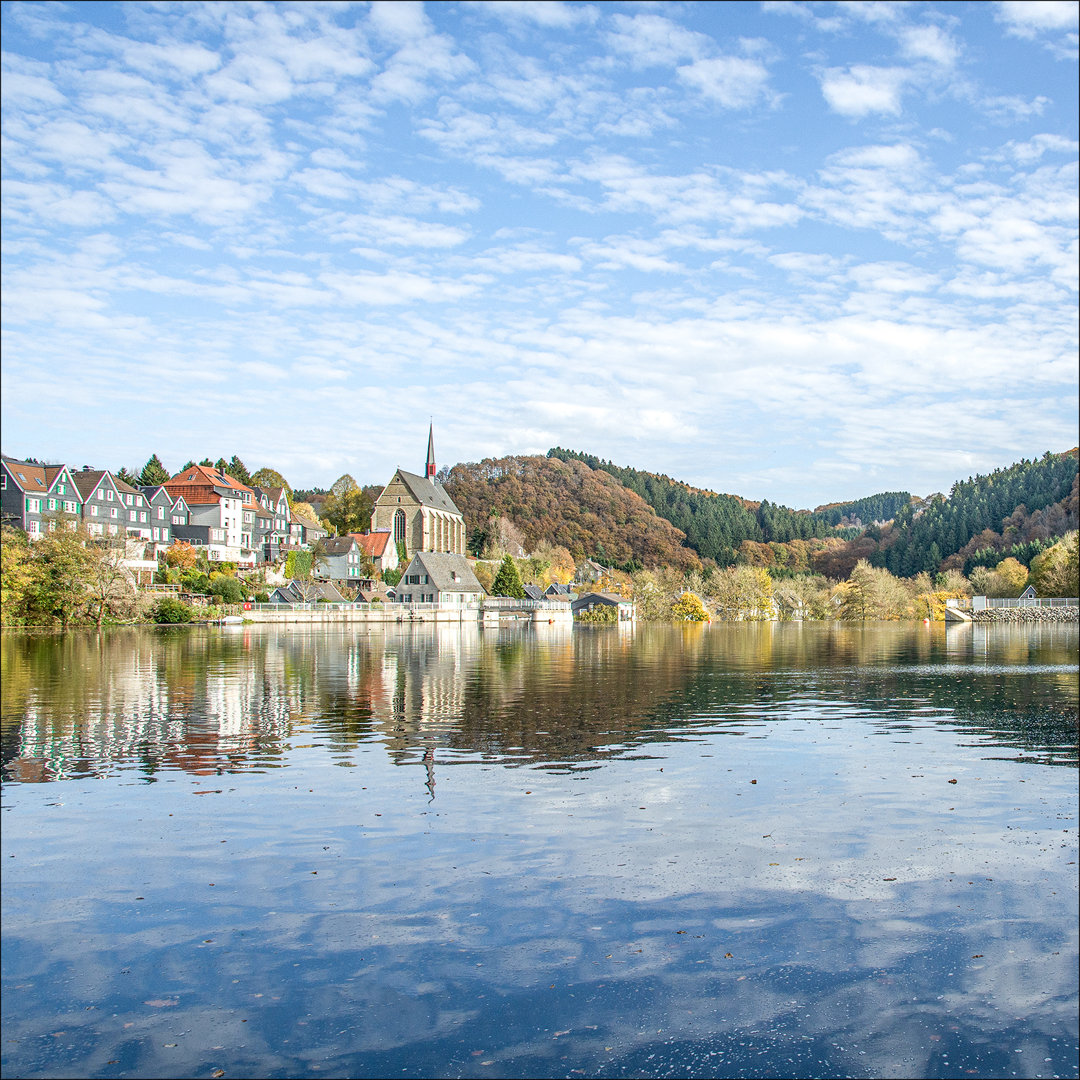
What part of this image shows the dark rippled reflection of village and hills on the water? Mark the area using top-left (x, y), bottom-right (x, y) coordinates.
top-left (2, 624), bottom-right (1078, 796)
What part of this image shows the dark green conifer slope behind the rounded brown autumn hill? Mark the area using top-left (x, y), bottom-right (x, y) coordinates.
top-left (548, 447), bottom-right (859, 566)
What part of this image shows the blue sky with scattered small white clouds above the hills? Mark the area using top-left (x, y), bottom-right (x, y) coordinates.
top-left (2, 0), bottom-right (1078, 508)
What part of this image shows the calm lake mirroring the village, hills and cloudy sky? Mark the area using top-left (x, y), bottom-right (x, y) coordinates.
top-left (0, 623), bottom-right (1078, 1078)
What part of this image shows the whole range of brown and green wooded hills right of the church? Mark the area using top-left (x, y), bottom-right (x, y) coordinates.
top-left (446, 448), bottom-right (1080, 579)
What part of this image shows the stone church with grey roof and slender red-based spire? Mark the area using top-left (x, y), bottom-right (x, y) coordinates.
top-left (372, 426), bottom-right (465, 566)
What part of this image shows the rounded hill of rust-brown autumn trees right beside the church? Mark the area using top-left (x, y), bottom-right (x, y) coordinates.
top-left (444, 456), bottom-right (701, 569)
